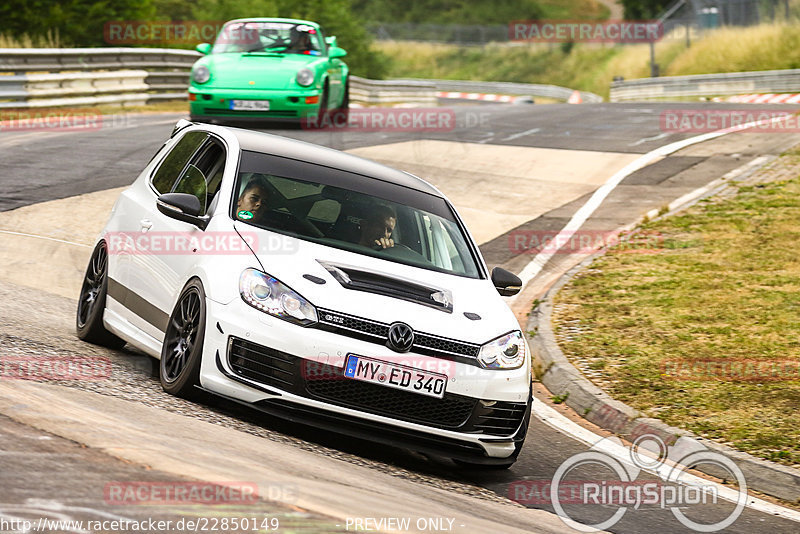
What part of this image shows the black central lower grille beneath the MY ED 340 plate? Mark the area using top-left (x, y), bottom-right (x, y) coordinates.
top-left (303, 362), bottom-right (477, 429)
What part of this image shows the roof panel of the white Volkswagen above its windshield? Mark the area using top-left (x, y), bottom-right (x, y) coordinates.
top-left (222, 128), bottom-right (444, 197)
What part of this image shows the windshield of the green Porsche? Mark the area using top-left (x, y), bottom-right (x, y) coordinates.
top-left (216, 21), bottom-right (322, 56)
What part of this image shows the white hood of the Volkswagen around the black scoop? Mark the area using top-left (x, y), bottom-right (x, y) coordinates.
top-left (235, 222), bottom-right (519, 344)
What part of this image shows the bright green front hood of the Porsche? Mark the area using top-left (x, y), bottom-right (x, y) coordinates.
top-left (198, 53), bottom-right (323, 89)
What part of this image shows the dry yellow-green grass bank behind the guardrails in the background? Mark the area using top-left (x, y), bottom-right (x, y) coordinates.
top-left (373, 23), bottom-right (800, 97)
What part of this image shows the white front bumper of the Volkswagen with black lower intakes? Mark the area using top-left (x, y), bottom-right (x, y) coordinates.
top-left (200, 299), bottom-right (530, 464)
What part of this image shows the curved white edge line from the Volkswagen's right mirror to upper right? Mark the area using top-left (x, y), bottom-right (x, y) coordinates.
top-left (506, 116), bottom-right (786, 306)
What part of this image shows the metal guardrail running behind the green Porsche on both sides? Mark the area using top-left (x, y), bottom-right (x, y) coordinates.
top-left (0, 48), bottom-right (602, 109)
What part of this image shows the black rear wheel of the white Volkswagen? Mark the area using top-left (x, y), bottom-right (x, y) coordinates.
top-left (75, 241), bottom-right (125, 349)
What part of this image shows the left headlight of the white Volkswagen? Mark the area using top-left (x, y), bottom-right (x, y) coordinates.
top-left (239, 269), bottom-right (317, 326)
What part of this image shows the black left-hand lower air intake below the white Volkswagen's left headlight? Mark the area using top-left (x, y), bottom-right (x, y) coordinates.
top-left (228, 337), bottom-right (300, 390)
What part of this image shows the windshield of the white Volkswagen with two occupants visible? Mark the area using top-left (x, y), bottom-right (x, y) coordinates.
top-left (232, 151), bottom-right (480, 278)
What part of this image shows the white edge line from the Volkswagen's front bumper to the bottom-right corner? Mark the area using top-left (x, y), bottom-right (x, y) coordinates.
top-left (532, 399), bottom-right (800, 523)
